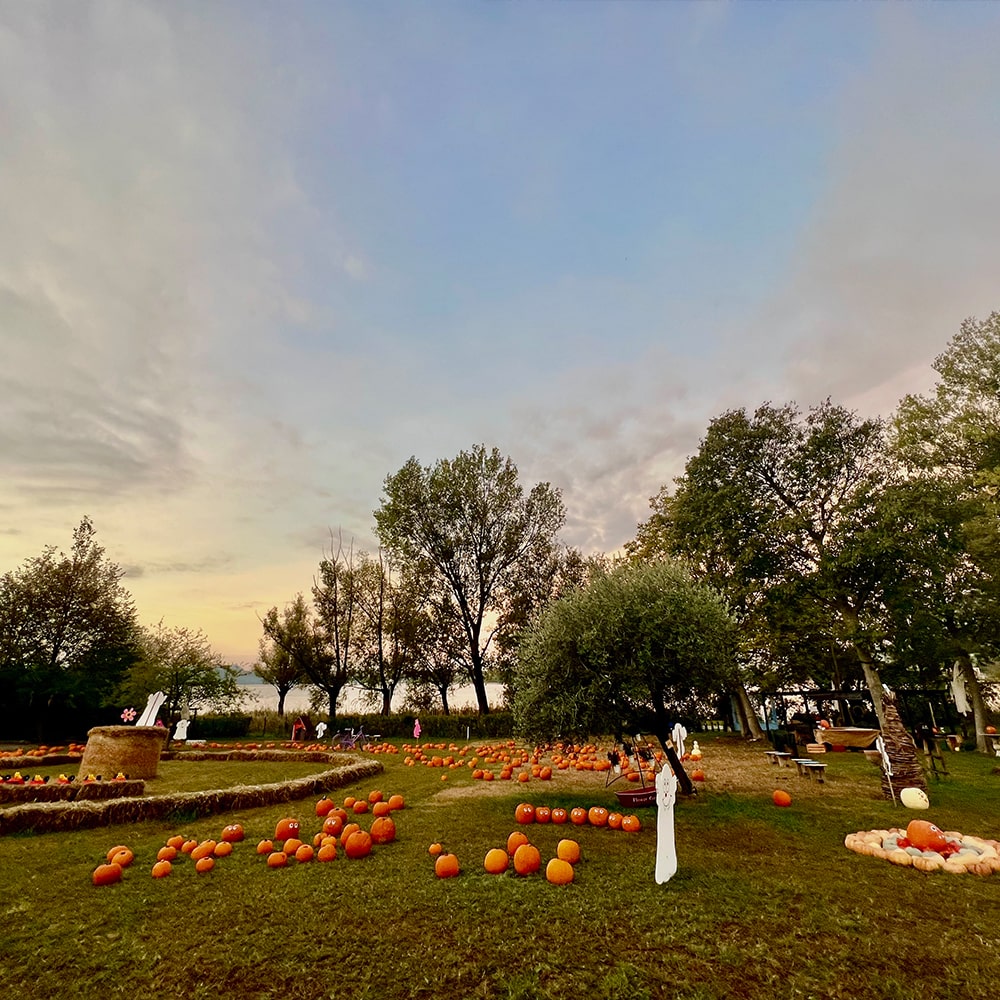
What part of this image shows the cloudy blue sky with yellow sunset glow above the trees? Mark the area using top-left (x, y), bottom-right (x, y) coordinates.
top-left (0, 0), bottom-right (1000, 664)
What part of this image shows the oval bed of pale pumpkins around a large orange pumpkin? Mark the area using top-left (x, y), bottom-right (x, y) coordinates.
top-left (844, 819), bottom-right (1000, 875)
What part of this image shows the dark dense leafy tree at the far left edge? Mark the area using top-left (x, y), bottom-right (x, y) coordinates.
top-left (0, 517), bottom-right (137, 738)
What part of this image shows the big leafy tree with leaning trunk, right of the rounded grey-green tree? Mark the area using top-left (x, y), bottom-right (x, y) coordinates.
top-left (671, 400), bottom-right (901, 720)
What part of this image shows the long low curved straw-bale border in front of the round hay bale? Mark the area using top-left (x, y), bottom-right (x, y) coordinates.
top-left (0, 752), bottom-right (384, 836)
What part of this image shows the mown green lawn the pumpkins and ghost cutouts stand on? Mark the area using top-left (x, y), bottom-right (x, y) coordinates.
top-left (0, 740), bottom-right (1000, 1000)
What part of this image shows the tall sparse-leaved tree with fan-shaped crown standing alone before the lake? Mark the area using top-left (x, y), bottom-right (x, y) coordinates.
top-left (375, 445), bottom-right (565, 713)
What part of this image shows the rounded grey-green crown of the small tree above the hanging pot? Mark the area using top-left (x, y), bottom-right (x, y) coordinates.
top-left (514, 560), bottom-right (735, 745)
